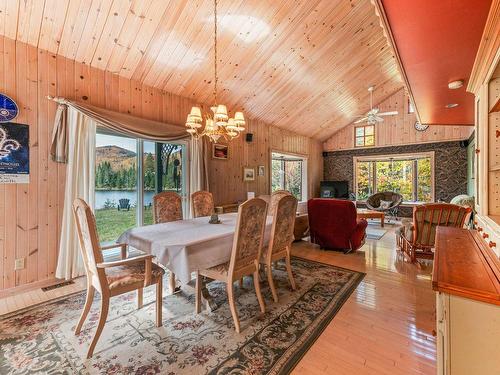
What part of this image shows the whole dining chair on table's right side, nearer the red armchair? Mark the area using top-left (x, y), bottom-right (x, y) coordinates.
top-left (260, 194), bottom-right (297, 302)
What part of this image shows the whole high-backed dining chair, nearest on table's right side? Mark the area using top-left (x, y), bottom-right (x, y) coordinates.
top-left (195, 198), bottom-right (267, 333)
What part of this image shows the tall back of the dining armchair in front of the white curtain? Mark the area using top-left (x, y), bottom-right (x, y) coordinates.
top-left (73, 198), bottom-right (104, 277)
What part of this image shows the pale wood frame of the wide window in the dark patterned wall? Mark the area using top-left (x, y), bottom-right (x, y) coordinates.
top-left (352, 151), bottom-right (436, 204)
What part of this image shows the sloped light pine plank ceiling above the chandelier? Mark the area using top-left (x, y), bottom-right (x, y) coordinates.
top-left (0, 0), bottom-right (403, 140)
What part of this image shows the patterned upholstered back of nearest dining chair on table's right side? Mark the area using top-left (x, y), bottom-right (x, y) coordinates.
top-left (229, 198), bottom-right (267, 274)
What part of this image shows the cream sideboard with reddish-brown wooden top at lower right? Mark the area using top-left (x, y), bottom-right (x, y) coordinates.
top-left (432, 227), bottom-right (500, 375)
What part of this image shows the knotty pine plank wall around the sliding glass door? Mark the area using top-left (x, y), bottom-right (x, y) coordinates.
top-left (0, 37), bottom-right (323, 296)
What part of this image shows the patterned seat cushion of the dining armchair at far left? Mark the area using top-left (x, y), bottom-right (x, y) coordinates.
top-left (106, 262), bottom-right (165, 289)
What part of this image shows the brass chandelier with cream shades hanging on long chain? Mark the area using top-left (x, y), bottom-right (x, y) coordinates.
top-left (186, 0), bottom-right (245, 142)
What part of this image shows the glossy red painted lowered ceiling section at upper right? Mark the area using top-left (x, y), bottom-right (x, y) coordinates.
top-left (382, 0), bottom-right (491, 125)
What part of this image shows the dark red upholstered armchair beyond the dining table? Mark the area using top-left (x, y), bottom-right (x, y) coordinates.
top-left (307, 198), bottom-right (368, 253)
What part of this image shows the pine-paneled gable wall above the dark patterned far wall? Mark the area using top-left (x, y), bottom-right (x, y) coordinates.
top-left (323, 89), bottom-right (474, 151)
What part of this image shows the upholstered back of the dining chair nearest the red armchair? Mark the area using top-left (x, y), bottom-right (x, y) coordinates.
top-left (269, 194), bottom-right (297, 254)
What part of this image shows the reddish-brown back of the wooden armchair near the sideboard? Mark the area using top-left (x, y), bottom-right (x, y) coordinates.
top-left (412, 203), bottom-right (472, 247)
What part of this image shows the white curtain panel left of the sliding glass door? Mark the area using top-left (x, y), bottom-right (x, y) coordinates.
top-left (53, 107), bottom-right (96, 280)
